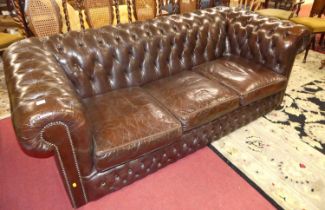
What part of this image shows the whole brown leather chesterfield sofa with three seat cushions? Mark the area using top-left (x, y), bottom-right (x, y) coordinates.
top-left (4, 7), bottom-right (309, 207)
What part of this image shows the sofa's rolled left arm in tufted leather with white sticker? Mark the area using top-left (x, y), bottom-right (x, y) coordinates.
top-left (3, 38), bottom-right (92, 174)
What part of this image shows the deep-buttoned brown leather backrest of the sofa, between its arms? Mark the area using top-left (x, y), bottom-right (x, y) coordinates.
top-left (44, 9), bottom-right (226, 97)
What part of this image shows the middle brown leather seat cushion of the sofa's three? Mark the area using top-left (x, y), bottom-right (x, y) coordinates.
top-left (144, 71), bottom-right (239, 131)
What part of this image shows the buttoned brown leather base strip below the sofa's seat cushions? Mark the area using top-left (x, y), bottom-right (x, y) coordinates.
top-left (83, 92), bottom-right (284, 201)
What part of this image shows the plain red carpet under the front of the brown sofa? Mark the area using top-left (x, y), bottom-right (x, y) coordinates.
top-left (0, 118), bottom-right (275, 210)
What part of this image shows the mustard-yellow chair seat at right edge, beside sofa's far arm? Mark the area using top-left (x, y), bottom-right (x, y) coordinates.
top-left (290, 17), bottom-right (325, 33)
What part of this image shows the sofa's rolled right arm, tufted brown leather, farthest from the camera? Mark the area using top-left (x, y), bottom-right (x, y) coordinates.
top-left (220, 8), bottom-right (311, 77)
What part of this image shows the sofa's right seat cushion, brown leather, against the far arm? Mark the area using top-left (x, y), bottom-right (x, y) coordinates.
top-left (193, 56), bottom-right (287, 105)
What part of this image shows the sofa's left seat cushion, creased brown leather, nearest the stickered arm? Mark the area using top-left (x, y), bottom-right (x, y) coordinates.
top-left (84, 88), bottom-right (182, 170)
